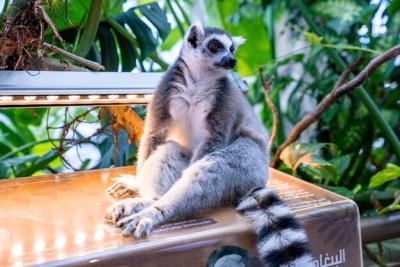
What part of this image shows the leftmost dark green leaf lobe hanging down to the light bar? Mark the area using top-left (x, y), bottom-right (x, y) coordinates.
top-left (97, 23), bottom-right (119, 71)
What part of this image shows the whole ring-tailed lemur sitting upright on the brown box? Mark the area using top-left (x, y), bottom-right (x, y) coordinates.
top-left (106, 23), bottom-right (313, 266)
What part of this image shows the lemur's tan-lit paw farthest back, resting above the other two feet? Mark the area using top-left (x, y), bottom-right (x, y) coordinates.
top-left (107, 174), bottom-right (139, 200)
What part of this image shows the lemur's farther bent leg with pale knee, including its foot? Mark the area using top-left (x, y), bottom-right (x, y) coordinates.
top-left (106, 141), bottom-right (189, 223)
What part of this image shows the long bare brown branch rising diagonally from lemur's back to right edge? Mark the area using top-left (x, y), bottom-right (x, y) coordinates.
top-left (271, 45), bottom-right (400, 167)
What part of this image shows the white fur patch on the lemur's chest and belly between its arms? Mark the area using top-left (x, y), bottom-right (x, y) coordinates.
top-left (167, 82), bottom-right (216, 152)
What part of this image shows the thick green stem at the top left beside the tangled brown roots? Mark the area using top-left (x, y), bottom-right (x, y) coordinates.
top-left (76, 0), bottom-right (103, 57)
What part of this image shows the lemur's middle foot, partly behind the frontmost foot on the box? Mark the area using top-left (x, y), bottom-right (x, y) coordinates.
top-left (105, 198), bottom-right (152, 224)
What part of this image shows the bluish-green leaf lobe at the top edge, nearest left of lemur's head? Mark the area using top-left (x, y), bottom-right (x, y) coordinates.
top-left (138, 2), bottom-right (171, 40)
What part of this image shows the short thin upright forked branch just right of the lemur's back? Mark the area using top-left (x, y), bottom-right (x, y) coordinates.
top-left (258, 66), bottom-right (279, 149)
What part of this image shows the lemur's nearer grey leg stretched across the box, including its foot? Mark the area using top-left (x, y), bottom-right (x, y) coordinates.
top-left (117, 138), bottom-right (267, 238)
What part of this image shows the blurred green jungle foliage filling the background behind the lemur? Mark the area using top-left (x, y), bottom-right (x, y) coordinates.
top-left (0, 0), bottom-right (400, 260)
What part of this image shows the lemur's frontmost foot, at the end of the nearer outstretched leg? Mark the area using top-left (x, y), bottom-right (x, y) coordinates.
top-left (117, 206), bottom-right (164, 239)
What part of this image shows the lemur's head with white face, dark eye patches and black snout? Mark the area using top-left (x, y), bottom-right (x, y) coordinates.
top-left (181, 22), bottom-right (245, 71)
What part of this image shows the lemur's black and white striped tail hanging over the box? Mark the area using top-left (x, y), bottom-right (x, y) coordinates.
top-left (236, 188), bottom-right (315, 267)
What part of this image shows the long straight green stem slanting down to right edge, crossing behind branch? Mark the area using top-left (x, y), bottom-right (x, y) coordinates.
top-left (294, 0), bottom-right (400, 162)
